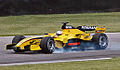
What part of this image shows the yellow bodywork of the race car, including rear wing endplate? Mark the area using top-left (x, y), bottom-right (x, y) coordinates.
top-left (5, 27), bottom-right (106, 51)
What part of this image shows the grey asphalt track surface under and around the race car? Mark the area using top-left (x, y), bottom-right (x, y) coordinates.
top-left (0, 33), bottom-right (120, 64)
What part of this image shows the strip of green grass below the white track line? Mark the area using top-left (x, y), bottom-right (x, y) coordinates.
top-left (0, 58), bottom-right (120, 70)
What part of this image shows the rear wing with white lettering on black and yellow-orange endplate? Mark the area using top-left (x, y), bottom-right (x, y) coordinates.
top-left (77, 26), bottom-right (106, 33)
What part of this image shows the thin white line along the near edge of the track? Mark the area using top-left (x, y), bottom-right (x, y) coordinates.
top-left (0, 57), bottom-right (111, 66)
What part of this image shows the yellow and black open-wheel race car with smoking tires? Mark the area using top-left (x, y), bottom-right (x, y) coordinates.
top-left (6, 22), bottom-right (108, 53)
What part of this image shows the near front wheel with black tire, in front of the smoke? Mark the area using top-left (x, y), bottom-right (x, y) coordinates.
top-left (40, 37), bottom-right (55, 54)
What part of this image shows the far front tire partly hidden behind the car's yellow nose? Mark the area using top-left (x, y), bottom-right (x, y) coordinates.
top-left (12, 35), bottom-right (25, 53)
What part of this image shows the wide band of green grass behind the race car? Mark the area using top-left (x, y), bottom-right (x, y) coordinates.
top-left (0, 12), bottom-right (120, 35)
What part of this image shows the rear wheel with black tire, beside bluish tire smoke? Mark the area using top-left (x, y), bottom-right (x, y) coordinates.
top-left (92, 33), bottom-right (108, 50)
